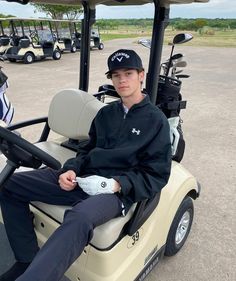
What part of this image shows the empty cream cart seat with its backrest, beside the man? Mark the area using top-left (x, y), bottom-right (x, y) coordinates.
top-left (33, 89), bottom-right (105, 165)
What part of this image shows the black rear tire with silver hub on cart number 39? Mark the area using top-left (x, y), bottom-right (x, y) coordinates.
top-left (165, 196), bottom-right (194, 257)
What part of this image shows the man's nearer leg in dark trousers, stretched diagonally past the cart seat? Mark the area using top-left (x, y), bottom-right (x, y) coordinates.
top-left (17, 194), bottom-right (122, 281)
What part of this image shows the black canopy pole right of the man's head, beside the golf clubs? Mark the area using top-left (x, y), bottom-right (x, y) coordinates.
top-left (146, 0), bottom-right (170, 104)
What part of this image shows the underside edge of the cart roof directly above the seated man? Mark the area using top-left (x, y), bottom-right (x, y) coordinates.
top-left (24, 0), bottom-right (209, 6)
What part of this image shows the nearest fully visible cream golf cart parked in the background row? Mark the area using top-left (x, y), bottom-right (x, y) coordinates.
top-left (5, 18), bottom-right (61, 64)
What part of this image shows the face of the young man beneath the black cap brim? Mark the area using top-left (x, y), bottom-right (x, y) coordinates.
top-left (111, 69), bottom-right (144, 98)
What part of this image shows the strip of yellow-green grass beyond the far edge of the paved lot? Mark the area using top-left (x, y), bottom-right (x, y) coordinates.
top-left (101, 27), bottom-right (236, 48)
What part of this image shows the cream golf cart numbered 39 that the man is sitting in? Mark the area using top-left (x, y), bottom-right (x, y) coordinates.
top-left (0, 0), bottom-right (207, 281)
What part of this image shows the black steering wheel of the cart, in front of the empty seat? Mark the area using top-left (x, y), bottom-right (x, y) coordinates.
top-left (0, 126), bottom-right (61, 170)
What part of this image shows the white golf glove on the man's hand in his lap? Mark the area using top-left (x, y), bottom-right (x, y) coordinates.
top-left (76, 176), bottom-right (115, 195)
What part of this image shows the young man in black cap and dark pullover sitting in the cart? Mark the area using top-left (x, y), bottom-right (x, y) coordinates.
top-left (0, 49), bottom-right (171, 281)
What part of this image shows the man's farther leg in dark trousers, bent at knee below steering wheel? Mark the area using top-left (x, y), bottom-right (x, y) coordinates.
top-left (0, 166), bottom-right (88, 280)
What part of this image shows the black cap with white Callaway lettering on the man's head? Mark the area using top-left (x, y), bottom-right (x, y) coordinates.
top-left (106, 49), bottom-right (143, 74)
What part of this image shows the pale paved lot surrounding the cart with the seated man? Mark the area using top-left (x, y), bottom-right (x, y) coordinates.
top-left (0, 39), bottom-right (236, 281)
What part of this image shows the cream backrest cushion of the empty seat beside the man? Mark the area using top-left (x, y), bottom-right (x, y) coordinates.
top-left (48, 89), bottom-right (105, 139)
